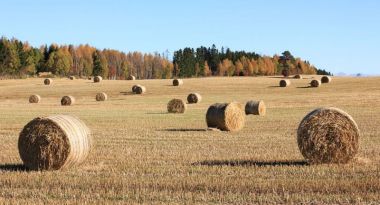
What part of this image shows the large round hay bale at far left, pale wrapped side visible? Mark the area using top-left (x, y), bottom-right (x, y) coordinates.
top-left (18, 115), bottom-right (92, 170)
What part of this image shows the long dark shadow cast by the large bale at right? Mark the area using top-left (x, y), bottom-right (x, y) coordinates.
top-left (191, 160), bottom-right (309, 167)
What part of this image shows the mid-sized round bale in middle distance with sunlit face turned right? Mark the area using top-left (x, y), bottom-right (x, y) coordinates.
top-left (206, 102), bottom-right (245, 131)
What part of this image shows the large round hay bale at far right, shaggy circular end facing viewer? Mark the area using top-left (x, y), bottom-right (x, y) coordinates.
top-left (297, 108), bottom-right (360, 163)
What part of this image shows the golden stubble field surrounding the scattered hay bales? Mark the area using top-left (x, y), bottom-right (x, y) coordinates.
top-left (0, 76), bottom-right (380, 204)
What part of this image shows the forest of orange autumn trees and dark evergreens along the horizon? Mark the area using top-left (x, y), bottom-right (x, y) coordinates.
top-left (0, 37), bottom-right (331, 80)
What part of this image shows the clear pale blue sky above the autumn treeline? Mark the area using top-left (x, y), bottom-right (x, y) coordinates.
top-left (0, 0), bottom-right (380, 74)
